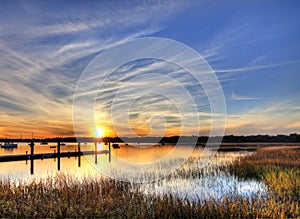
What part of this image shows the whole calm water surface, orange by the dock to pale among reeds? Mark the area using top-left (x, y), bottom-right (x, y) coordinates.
top-left (0, 143), bottom-right (266, 199)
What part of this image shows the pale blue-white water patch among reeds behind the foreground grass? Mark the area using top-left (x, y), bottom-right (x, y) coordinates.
top-left (141, 175), bottom-right (266, 201)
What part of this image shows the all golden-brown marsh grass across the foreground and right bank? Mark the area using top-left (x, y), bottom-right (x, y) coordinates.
top-left (0, 146), bottom-right (300, 218)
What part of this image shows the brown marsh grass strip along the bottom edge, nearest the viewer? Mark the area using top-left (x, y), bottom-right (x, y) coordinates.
top-left (0, 176), bottom-right (299, 218)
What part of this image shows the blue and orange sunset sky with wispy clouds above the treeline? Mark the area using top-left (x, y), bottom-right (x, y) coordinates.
top-left (0, 0), bottom-right (300, 138)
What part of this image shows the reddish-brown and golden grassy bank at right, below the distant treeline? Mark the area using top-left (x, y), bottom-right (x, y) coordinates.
top-left (230, 146), bottom-right (300, 198)
